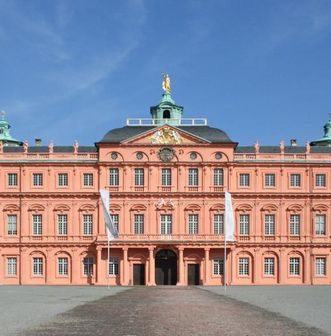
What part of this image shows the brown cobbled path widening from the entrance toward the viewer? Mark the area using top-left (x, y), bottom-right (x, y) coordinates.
top-left (22, 287), bottom-right (325, 336)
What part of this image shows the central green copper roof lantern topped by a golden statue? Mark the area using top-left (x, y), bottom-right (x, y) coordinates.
top-left (150, 74), bottom-right (184, 126)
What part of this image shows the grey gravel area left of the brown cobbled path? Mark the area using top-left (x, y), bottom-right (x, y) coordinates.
top-left (0, 286), bottom-right (127, 336)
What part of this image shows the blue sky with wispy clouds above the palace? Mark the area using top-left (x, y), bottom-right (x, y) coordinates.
top-left (0, 0), bottom-right (331, 145)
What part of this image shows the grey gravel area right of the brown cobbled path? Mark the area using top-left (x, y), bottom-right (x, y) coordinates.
top-left (201, 286), bottom-right (331, 333)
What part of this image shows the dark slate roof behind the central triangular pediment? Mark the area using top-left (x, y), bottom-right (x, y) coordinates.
top-left (99, 126), bottom-right (234, 144)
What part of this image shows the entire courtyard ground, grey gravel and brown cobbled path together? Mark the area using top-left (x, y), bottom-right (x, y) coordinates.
top-left (0, 286), bottom-right (331, 336)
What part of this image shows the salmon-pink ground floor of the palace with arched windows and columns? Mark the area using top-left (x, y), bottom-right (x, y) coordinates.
top-left (0, 242), bottom-right (331, 286)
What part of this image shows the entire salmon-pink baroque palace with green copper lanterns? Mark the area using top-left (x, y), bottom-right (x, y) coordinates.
top-left (0, 78), bottom-right (331, 286)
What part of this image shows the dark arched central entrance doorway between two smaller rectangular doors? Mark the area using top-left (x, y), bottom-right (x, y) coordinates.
top-left (155, 250), bottom-right (177, 285)
